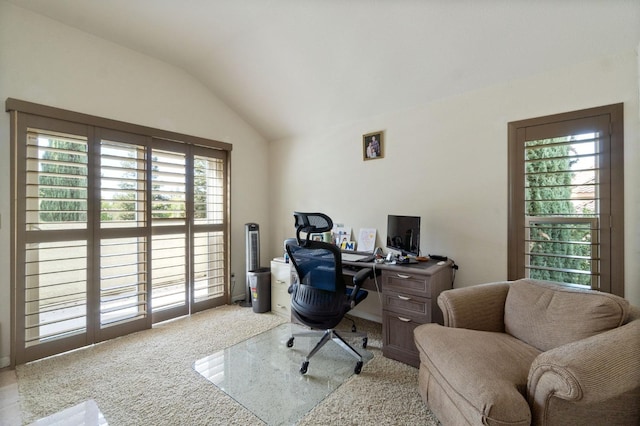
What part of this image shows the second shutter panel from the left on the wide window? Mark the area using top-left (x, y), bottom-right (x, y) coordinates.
top-left (96, 129), bottom-right (150, 340)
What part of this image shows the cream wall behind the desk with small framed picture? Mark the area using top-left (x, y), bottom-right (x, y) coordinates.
top-left (270, 51), bottom-right (640, 320)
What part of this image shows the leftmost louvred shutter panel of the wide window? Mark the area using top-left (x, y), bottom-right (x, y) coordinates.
top-left (16, 119), bottom-right (92, 356)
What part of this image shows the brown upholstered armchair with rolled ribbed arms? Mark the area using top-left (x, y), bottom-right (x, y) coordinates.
top-left (414, 280), bottom-right (640, 426)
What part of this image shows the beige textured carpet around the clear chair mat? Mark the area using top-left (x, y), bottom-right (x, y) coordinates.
top-left (17, 306), bottom-right (438, 426)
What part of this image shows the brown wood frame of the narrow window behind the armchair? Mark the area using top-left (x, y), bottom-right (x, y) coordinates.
top-left (508, 103), bottom-right (624, 297)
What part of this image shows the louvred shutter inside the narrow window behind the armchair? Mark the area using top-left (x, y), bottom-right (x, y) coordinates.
top-left (524, 132), bottom-right (608, 289)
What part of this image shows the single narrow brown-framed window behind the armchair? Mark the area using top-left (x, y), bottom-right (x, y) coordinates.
top-left (509, 104), bottom-right (624, 296)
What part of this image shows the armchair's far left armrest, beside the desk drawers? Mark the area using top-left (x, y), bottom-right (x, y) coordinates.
top-left (438, 281), bottom-right (509, 332)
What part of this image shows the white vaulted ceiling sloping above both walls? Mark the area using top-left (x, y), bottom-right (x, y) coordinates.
top-left (8, 0), bottom-right (640, 140)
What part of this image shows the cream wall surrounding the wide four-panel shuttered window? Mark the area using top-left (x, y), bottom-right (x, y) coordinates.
top-left (0, 0), bottom-right (270, 367)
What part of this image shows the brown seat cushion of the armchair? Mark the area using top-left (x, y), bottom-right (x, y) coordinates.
top-left (414, 324), bottom-right (540, 425)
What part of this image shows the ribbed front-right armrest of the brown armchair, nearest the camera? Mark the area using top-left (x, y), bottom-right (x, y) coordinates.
top-left (527, 320), bottom-right (640, 410)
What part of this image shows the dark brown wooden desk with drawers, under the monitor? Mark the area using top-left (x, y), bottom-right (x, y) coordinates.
top-left (342, 260), bottom-right (453, 367)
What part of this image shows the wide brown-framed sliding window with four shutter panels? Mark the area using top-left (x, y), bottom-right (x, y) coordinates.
top-left (7, 99), bottom-right (231, 364)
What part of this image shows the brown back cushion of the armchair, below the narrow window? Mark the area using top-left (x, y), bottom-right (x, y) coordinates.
top-left (504, 279), bottom-right (629, 351)
